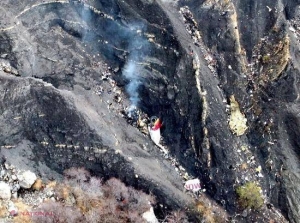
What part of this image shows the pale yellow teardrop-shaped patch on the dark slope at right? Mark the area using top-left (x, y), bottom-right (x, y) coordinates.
top-left (229, 95), bottom-right (248, 136)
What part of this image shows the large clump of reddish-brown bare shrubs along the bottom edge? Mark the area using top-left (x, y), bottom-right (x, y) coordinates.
top-left (32, 168), bottom-right (155, 223)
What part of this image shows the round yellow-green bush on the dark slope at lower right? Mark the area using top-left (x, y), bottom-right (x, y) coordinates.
top-left (236, 182), bottom-right (264, 209)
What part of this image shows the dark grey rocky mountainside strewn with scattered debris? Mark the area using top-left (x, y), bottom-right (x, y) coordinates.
top-left (0, 0), bottom-right (300, 222)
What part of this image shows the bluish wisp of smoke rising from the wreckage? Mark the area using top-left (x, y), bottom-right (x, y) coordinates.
top-left (75, 2), bottom-right (150, 115)
